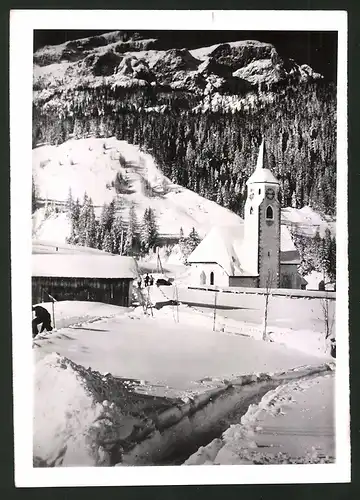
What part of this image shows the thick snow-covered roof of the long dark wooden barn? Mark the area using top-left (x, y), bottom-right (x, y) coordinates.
top-left (32, 254), bottom-right (137, 279)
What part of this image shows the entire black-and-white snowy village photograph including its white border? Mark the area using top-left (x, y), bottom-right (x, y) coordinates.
top-left (10, 11), bottom-right (350, 486)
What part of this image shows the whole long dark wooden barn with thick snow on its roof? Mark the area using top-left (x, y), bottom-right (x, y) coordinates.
top-left (32, 253), bottom-right (136, 307)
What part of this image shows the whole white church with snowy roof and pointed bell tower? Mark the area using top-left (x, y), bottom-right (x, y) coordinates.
top-left (187, 141), bottom-right (306, 289)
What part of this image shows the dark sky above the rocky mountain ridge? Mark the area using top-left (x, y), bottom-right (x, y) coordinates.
top-left (34, 29), bottom-right (337, 81)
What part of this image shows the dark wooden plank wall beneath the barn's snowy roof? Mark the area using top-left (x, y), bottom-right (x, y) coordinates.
top-left (32, 276), bottom-right (132, 307)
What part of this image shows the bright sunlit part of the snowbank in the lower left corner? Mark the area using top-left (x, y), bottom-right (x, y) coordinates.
top-left (33, 353), bottom-right (131, 466)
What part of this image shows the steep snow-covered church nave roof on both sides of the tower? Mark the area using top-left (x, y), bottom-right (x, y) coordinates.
top-left (187, 223), bottom-right (300, 276)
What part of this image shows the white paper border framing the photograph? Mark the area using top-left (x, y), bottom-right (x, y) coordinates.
top-left (10, 10), bottom-right (350, 487)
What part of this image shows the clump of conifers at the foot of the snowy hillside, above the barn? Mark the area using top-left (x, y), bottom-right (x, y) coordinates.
top-left (66, 190), bottom-right (159, 255)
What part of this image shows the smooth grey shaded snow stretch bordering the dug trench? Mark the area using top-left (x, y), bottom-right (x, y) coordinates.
top-left (34, 311), bottom-right (319, 390)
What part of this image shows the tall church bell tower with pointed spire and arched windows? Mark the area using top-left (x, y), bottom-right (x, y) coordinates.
top-left (244, 140), bottom-right (281, 288)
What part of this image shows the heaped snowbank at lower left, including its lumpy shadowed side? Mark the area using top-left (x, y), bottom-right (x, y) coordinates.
top-left (33, 353), bottom-right (179, 467)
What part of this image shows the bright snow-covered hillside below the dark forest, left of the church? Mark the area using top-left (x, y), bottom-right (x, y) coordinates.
top-left (33, 138), bottom-right (241, 241)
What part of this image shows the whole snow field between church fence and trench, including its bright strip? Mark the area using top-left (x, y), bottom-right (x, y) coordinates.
top-left (34, 286), bottom-right (330, 390)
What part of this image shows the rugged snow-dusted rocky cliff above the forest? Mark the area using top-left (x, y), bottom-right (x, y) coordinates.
top-left (34, 32), bottom-right (321, 104)
